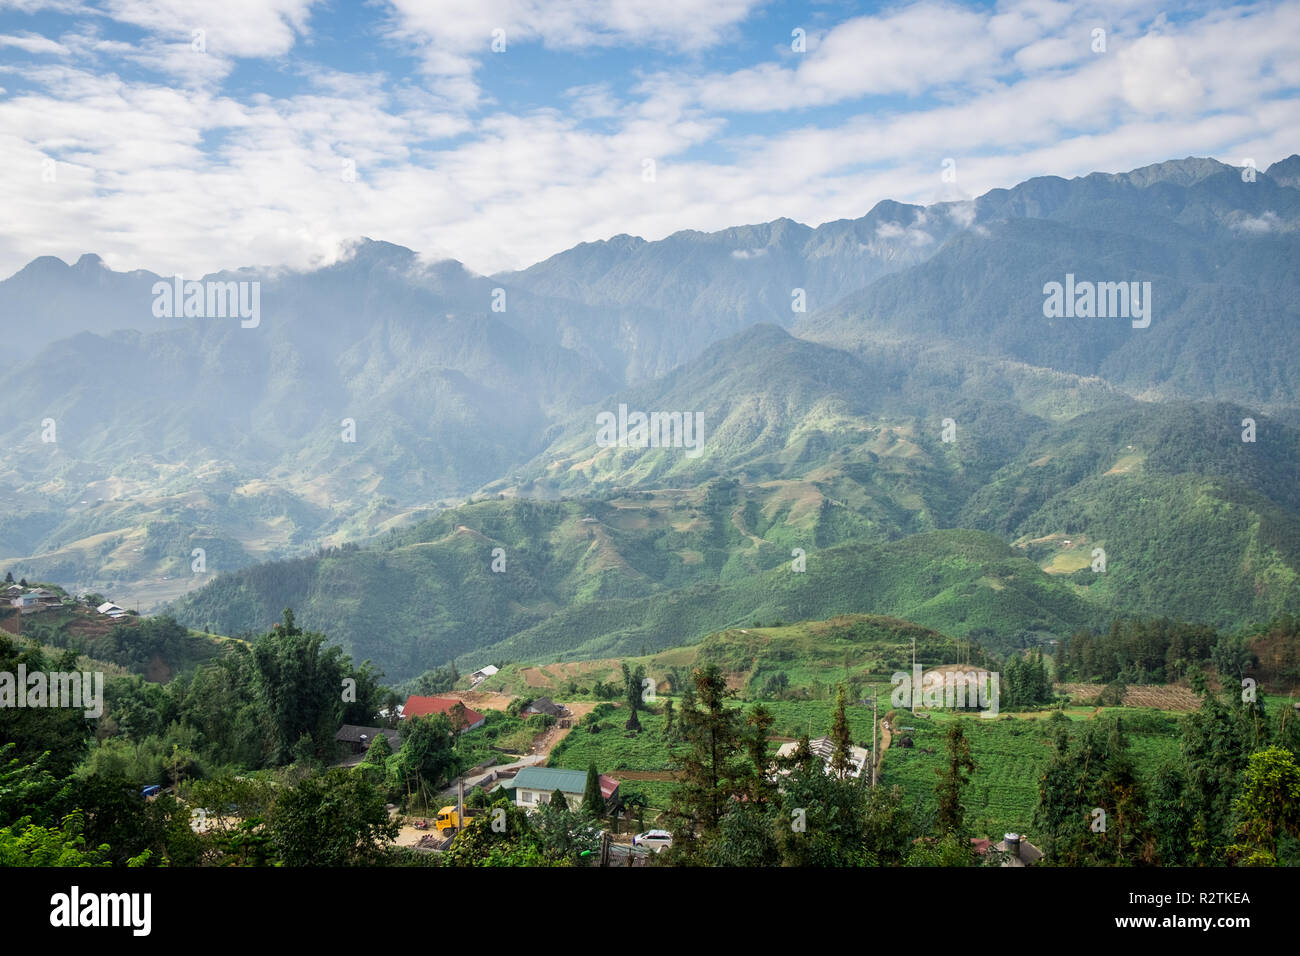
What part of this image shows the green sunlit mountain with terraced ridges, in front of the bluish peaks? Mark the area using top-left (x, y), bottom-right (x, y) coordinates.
top-left (167, 325), bottom-right (1300, 678)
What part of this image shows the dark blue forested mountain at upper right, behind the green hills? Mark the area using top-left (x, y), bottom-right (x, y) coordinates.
top-left (798, 164), bottom-right (1300, 408)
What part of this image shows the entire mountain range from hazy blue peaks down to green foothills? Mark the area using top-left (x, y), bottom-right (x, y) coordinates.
top-left (0, 156), bottom-right (1300, 679)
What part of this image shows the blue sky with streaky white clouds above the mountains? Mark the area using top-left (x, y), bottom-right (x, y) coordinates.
top-left (0, 0), bottom-right (1300, 276)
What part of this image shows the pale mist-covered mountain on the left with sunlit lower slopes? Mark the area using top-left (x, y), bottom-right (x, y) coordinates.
top-left (0, 242), bottom-right (619, 597)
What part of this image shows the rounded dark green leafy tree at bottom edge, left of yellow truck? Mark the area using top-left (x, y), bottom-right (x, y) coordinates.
top-left (267, 767), bottom-right (398, 866)
